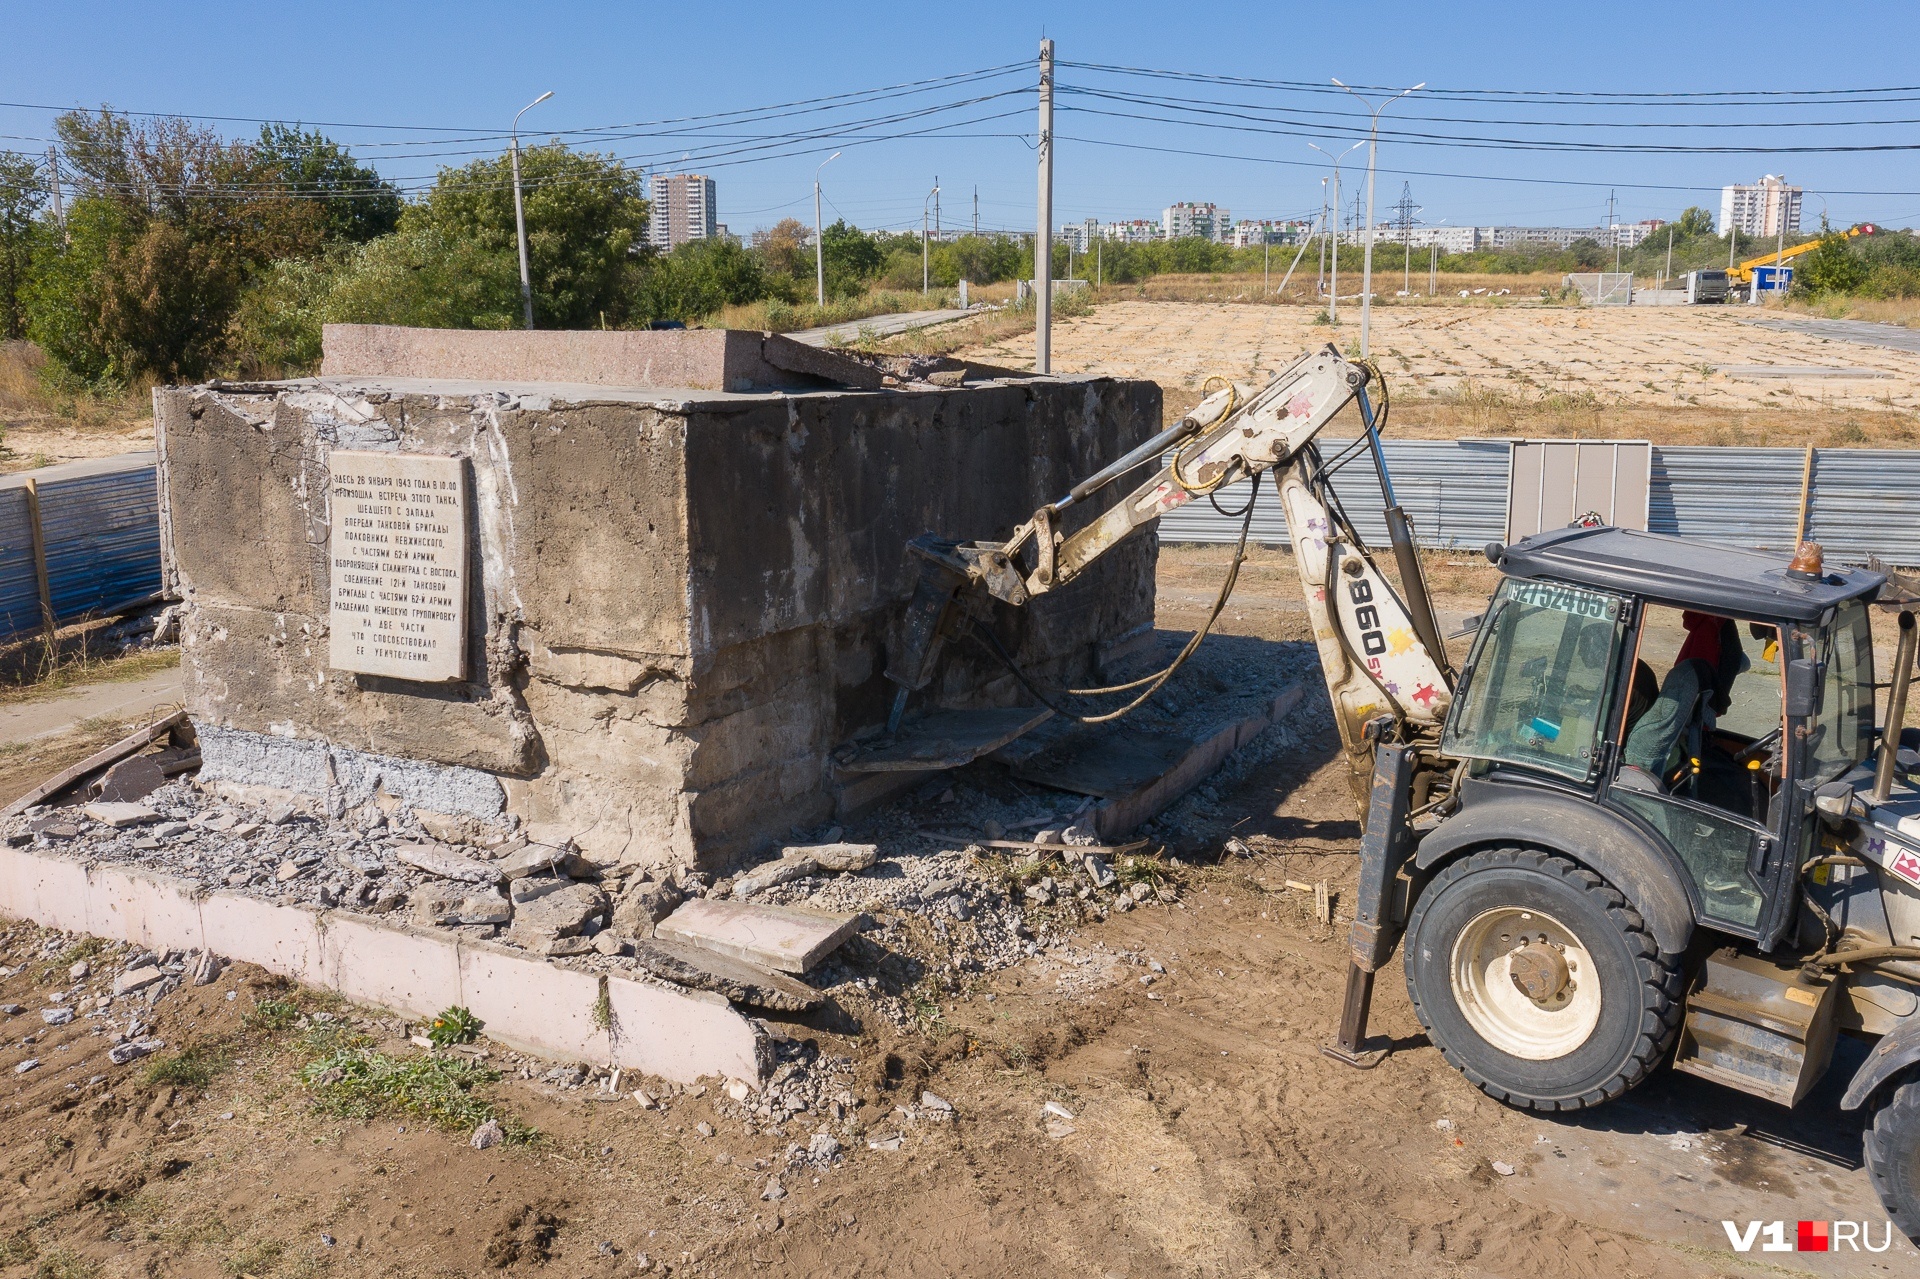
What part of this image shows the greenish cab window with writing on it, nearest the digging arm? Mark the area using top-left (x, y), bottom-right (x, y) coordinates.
top-left (1442, 578), bottom-right (1626, 782)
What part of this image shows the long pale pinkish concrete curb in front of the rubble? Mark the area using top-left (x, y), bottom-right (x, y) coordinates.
top-left (0, 849), bottom-right (768, 1083)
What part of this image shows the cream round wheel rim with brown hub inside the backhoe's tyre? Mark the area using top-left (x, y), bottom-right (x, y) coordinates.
top-left (1448, 906), bottom-right (1601, 1062)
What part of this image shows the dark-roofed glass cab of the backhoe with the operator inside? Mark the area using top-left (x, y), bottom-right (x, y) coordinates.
top-left (1442, 528), bottom-right (1884, 951)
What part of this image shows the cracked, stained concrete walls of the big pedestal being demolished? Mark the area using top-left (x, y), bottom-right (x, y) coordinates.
top-left (156, 368), bottom-right (1160, 864)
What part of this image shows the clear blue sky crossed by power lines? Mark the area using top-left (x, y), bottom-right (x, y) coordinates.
top-left (0, 0), bottom-right (1920, 232)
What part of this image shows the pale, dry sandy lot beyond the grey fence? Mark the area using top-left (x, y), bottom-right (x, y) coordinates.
top-left (962, 302), bottom-right (1920, 447)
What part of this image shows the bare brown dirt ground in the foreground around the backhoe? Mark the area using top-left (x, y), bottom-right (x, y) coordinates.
top-left (0, 547), bottom-right (1916, 1279)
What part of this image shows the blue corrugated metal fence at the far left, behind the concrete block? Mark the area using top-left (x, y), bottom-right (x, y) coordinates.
top-left (0, 453), bottom-right (159, 640)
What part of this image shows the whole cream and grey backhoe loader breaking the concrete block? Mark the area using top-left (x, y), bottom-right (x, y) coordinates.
top-left (887, 346), bottom-right (1920, 1241)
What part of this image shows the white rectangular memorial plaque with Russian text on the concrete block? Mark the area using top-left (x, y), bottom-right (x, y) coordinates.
top-left (326, 449), bottom-right (467, 682)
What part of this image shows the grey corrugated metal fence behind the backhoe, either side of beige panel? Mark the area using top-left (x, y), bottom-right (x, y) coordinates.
top-left (1160, 440), bottom-right (1920, 565)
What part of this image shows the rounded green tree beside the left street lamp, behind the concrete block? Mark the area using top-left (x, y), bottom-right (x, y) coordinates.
top-left (419, 142), bottom-right (647, 328)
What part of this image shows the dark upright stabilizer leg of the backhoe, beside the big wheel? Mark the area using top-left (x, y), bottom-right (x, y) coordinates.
top-left (1321, 737), bottom-right (1415, 1070)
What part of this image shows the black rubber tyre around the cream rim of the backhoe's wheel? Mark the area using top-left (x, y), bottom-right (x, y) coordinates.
top-left (1405, 849), bottom-right (1684, 1110)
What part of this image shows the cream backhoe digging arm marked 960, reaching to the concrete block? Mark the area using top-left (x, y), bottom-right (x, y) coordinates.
top-left (887, 346), bottom-right (1452, 789)
